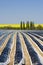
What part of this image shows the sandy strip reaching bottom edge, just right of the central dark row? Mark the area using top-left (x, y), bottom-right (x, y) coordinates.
top-left (19, 33), bottom-right (32, 65)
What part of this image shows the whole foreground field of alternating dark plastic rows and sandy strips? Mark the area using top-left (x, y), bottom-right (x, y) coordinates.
top-left (0, 30), bottom-right (43, 65)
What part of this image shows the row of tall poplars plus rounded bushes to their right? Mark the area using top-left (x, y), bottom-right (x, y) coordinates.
top-left (20, 21), bottom-right (43, 30)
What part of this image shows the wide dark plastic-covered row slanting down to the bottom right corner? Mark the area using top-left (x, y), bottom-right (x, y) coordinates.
top-left (21, 33), bottom-right (42, 65)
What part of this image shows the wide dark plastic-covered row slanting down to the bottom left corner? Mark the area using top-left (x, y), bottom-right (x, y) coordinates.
top-left (0, 35), bottom-right (13, 63)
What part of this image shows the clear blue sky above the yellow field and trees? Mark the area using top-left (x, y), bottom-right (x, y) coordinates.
top-left (0, 0), bottom-right (43, 24)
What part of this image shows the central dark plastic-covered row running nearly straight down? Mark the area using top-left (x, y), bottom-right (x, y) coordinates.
top-left (14, 33), bottom-right (22, 64)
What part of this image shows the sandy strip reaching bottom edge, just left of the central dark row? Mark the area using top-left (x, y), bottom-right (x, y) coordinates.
top-left (8, 34), bottom-right (16, 65)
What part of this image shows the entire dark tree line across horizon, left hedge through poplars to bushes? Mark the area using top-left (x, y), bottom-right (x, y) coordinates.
top-left (0, 21), bottom-right (43, 30)
